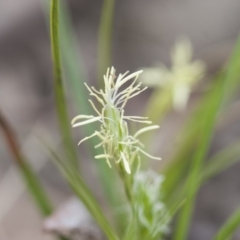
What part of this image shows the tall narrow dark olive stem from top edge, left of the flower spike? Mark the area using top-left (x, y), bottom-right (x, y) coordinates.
top-left (50, 0), bottom-right (78, 168)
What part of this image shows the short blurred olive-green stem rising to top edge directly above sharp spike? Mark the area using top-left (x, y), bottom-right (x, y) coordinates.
top-left (98, 0), bottom-right (115, 86)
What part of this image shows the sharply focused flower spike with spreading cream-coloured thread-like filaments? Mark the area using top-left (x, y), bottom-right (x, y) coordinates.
top-left (72, 67), bottom-right (160, 174)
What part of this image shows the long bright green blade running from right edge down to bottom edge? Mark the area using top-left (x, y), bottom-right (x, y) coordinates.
top-left (174, 33), bottom-right (240, 240)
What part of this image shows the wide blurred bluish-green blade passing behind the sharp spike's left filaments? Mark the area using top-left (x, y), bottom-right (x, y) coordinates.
top-left (59, 0), bottom-right (116, 208)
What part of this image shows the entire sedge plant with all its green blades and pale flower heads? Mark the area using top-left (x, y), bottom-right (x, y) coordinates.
top-left (0, 0), bottom-right (240, 240)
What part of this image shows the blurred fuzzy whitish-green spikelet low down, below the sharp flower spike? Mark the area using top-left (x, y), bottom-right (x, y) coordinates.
top-left (132, 170), bottom-right (170, 239)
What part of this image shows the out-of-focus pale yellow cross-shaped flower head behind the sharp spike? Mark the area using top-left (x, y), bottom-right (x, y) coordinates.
top-left (140, 39), bottom-right (205, 110)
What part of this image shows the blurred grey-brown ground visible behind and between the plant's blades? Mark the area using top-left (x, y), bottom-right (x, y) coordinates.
top-left (0, 0), bottom-right (240, 240)
